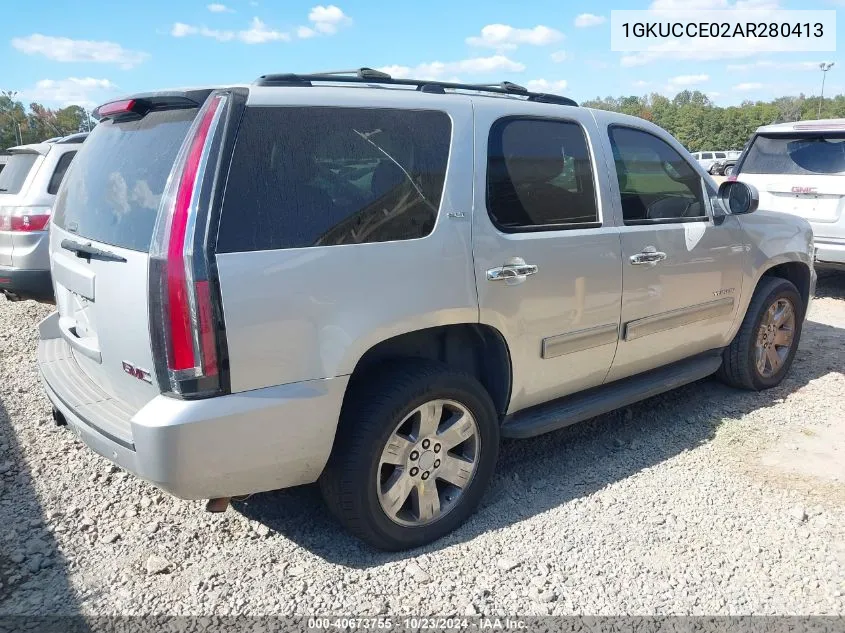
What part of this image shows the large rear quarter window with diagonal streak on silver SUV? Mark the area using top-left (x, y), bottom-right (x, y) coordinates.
top-left (218, 107), bottom-right (452, 252)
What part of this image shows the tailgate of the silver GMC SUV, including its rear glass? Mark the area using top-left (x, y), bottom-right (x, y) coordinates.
top-left (50, 103), bottom-right (197, 407)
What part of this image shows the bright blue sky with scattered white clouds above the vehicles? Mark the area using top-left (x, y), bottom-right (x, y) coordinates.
top-left (0, 0), bottom-right (845, 107)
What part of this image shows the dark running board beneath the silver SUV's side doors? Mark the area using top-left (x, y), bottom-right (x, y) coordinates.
top-left (502, 349), bottom-right (722, 438)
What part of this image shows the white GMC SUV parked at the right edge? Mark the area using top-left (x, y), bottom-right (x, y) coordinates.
top-left (737, 119), bottom-right (845, 269)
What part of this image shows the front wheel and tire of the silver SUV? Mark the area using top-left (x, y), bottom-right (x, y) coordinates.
top-left (717, 277), bottom-right (806, 391)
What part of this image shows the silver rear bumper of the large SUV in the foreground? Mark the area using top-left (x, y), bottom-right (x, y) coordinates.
top-left (38, 314), bottom-right (348, 499)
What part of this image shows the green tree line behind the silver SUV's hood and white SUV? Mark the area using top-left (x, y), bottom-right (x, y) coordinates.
top-left (581, 90), bottom-right (845, 152)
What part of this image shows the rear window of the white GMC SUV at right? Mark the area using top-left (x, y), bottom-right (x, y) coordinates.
top-left (742, 132), bottom-right (845, 175)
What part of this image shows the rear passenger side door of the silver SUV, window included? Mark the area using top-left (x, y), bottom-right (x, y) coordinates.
top-left (473, 108), bottom-right (622, 413)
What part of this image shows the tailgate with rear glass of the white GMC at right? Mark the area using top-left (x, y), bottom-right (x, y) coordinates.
top-left (738, 132), bottom-right (845, 227)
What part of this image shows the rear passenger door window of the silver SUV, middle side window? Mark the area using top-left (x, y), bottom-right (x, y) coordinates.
top-left (487, 118), bottom-right (599, 232)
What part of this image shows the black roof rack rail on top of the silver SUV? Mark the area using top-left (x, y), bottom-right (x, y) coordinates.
top-left (254, 68), bottom-right (578, 106)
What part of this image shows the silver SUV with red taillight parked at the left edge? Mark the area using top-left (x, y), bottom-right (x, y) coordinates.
top-left (0, 134), bottom-right (87, 302)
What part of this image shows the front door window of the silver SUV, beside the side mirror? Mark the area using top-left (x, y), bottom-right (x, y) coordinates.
top-left (610, 126), bottom-right (707, 225)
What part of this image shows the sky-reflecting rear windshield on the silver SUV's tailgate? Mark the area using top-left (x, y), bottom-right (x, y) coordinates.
top-left (53, 109), bottom-right (197, 252)
